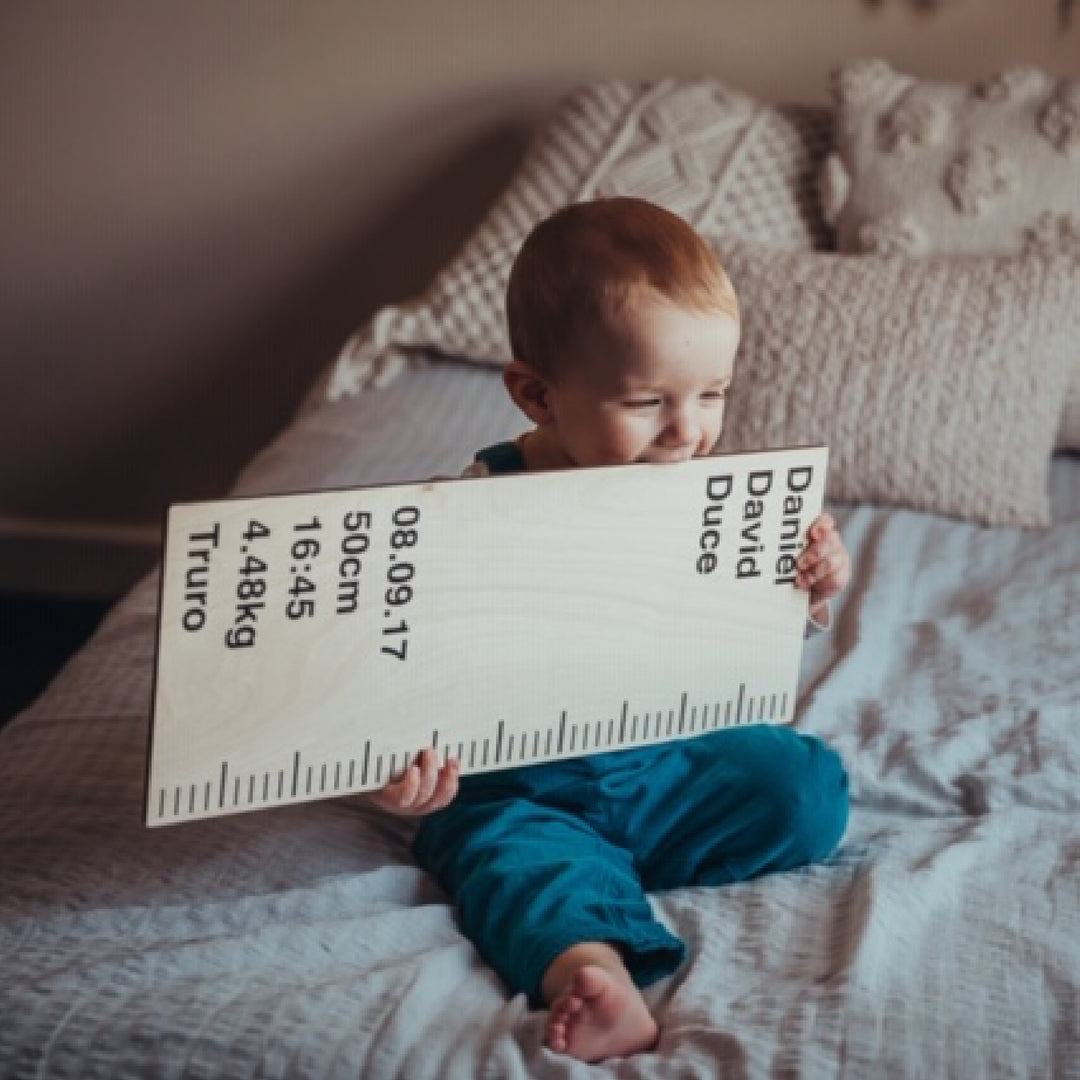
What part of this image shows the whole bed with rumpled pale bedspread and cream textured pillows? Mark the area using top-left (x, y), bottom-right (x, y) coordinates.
top-left (0, 62), bottom-right (1080, 1080)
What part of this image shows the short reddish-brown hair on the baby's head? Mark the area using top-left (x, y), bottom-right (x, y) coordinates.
top-left (507, 197), bottom-right (739, 375)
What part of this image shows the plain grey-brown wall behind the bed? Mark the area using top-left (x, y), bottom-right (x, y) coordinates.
top-left (0, 0), bottom-right (1080, 591)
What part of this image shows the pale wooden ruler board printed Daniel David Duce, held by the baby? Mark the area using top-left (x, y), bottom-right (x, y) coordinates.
top-left (146, 446), bottom-right (827, 825)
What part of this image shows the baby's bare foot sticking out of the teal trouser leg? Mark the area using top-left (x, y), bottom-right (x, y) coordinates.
top-left (544, 964), bottom-right (660, 1062)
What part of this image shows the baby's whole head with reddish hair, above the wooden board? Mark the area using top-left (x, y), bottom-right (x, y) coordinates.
top-left (505, 198), bottom-right (739, 465)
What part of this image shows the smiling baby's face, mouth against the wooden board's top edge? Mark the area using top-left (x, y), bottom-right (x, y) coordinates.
top-left (549, 294), bottom-right (739, 465)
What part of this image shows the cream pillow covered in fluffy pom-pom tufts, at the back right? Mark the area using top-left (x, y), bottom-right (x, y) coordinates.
top-left (822, 60), bottom-right (1080, 448)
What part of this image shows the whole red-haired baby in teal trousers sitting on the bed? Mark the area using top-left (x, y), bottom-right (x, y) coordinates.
top-left (372, 198), bottom-right (850, 1062)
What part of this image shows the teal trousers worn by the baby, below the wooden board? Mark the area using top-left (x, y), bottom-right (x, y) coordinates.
top-left (414, 725), bottom-right (848, 1008)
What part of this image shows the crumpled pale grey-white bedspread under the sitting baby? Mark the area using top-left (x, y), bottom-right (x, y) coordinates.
top-left (0, 363), bottom-right (1080, 1080)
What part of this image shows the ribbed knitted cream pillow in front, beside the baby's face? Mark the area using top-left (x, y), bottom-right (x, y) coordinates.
top-left (720, 241), bottom-right (1080, 525)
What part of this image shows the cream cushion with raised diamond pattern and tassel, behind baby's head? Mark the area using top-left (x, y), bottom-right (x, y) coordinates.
top-left (327, 79), bottom-right (832, 400)
